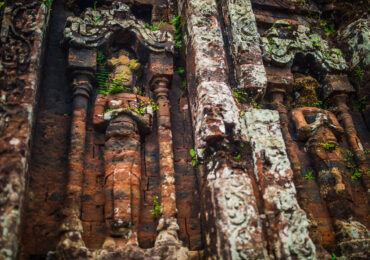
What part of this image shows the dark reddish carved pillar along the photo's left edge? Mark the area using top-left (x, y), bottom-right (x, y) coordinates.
top-left (0, 1), bottom-right (49, 259)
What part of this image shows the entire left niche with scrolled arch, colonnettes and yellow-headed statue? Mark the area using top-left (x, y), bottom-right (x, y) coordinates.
top-left (21, 1), bottom-right (202, 259)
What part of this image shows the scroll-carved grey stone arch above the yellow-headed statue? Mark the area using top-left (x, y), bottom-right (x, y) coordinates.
top-left (64, 2), bottom-right (174, 52)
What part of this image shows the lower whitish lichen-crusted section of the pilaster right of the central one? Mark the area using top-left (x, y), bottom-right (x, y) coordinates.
top-left (244, 109), bottom-right (316, 259)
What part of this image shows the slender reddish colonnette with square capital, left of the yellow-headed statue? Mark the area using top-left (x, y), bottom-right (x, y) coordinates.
top-left (61, 48), bottom-right (96, 238)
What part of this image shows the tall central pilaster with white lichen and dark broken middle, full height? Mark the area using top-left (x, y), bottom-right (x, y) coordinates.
top-left (185, 0), bottom-right (268, 259)
